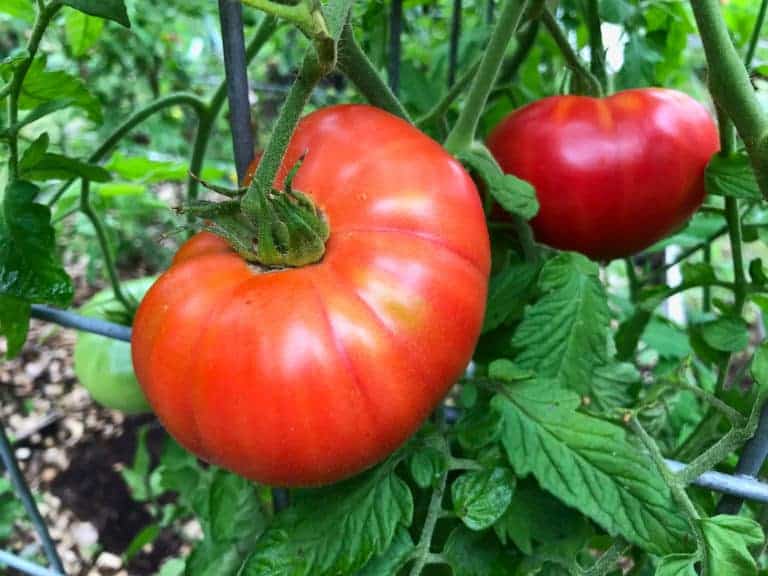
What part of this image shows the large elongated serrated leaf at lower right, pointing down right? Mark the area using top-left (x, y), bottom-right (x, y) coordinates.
top-left (492, 380), bottom-right (688, 554)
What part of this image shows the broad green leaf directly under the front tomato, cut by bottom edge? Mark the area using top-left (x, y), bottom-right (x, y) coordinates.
top-left (242, 453), bottom-right (413, 576)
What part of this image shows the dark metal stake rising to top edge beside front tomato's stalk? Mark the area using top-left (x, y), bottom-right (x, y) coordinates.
top-left (219, 0), bottom-right (254, 182)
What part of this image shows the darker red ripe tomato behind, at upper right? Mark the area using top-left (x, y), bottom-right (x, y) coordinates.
top-left (488, 88), bottom-right (719, 260)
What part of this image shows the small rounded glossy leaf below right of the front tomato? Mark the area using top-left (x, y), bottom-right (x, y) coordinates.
top-left (451, 468), bottom-right (516, 530)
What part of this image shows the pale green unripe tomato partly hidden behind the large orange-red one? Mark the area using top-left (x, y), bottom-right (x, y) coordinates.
top-left (75, 276), bottom-right (157, 414)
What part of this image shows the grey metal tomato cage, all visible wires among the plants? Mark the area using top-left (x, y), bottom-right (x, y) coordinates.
top-left (0, 0), bottom-right (768, 576)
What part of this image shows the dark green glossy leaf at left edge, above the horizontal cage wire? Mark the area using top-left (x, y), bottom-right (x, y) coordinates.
top-left (0, 180), bottom-right (73, 307)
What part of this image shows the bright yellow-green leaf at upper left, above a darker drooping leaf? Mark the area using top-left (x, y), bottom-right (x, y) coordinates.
top-left (19, 56), bottom-right (102, 123)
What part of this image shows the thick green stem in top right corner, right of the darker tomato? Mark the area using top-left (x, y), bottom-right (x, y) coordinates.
top-left (691, 0), bottom-right (768, 199)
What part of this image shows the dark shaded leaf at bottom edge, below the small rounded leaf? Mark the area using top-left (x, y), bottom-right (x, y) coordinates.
top-left (443, 526), bottom-right (516, 576)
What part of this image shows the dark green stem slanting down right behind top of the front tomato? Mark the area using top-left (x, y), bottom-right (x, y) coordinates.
top-left (338, 24), bottom-right (411, 122)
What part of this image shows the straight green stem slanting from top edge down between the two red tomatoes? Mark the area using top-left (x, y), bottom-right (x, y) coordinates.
top-left (445, 0), bottom-right (528, 154)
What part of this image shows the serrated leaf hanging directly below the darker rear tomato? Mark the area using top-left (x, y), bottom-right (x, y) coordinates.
top-left (512, 253), bottom-right (610, 395)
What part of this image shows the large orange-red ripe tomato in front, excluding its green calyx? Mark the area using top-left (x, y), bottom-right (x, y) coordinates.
top-left (133, 105), bottom-right (490, 486)
